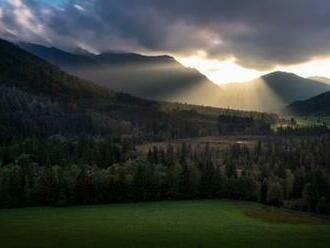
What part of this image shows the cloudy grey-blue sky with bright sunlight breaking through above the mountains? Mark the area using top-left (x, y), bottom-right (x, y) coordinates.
top-left (0, 0), bottom-right (330, 84)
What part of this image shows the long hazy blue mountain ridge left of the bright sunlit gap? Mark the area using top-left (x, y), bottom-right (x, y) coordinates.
top-left (20, 43), bottom-right (223, 106)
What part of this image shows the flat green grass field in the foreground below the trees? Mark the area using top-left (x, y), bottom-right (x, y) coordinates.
top-left (0, 200), bottom-right (330, 248)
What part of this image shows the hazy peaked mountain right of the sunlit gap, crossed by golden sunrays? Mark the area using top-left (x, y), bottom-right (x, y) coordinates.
top-left (222, 71), bottom-right (330, 112)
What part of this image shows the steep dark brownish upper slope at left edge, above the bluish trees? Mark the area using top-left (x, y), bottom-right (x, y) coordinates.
top-left (0, 39), bottom-right (111, 98)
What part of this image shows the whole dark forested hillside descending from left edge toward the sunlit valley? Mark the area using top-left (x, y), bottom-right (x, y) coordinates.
top-left (0, 40), bottom-right (277, 143)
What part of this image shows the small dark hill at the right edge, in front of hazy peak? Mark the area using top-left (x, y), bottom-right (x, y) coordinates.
top-left (286, 91), bottom-right (330, 115)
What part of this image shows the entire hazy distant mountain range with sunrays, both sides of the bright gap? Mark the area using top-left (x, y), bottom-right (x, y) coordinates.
top-left (20, 44), bottom-right (330, 112)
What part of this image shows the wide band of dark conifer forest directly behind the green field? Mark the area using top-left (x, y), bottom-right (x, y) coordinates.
top-left (0, 136), bottom-right (330, 214)
